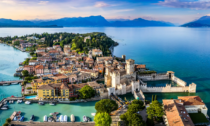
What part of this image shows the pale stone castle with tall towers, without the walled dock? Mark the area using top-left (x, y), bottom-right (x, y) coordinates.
top-left (105, 59), bottom-right (140, 96)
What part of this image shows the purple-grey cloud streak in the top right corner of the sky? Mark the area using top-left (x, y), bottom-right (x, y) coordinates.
top-left (156, 0), bottom-right (210, 10)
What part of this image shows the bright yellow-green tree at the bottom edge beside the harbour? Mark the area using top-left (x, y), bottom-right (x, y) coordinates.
top-left (94, 112), bottom-right (112, 126)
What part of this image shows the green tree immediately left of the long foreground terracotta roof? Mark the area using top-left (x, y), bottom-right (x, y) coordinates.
top-left (147, 100), bottom-right (164, 119)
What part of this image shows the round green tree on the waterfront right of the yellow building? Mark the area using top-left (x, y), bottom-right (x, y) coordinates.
top-left (79, 85), bottom-right (95, 99)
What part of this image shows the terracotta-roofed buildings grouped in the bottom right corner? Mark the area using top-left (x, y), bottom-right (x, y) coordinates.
top-left (163, 96), bottom-right (208, 126)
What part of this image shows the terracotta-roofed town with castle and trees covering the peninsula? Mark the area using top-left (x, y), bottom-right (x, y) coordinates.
top-left (0, 33), bottom-right (210, 126)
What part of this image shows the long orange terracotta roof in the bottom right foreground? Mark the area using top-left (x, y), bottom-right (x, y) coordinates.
top-left (163, 99), bottom-right (194, 126)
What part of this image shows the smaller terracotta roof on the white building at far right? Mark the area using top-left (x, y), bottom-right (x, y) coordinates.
top-left (178, 96), bottom-right (205, 105)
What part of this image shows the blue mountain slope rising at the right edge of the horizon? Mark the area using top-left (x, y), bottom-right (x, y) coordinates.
top-left (181, 16), bottom-right (210, 27)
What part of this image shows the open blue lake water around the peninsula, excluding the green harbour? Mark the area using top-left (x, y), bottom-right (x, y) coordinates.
top-left (0, 27), bottom-right (210, 124)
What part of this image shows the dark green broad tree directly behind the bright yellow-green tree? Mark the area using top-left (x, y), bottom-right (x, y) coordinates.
top-left (95, 99), bottom-right (118, 113)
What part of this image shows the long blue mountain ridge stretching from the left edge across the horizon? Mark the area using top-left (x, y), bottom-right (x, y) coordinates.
top-left (0, 16), bottom-right (174, 27)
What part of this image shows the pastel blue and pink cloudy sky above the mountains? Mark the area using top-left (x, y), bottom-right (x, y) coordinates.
top-left (0, 0), bottom-right (210, 24)
